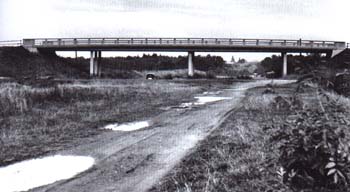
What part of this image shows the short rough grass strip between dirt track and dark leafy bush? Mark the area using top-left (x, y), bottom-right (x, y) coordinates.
top-left (150, 84), bottom-right (292, 192)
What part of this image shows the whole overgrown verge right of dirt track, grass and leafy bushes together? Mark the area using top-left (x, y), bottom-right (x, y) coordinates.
top-left (150, 84), bottom-right (350, 192)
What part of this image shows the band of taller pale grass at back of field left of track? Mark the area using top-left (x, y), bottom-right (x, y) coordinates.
top-left (0, 81), bottom-right (195, 116)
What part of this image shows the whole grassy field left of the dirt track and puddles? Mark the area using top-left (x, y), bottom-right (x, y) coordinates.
top-left (0, 80), bottom-right (230, 166)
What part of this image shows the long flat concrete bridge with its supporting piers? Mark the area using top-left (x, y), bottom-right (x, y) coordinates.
top-left (6, 38), bottom-right (347, 76)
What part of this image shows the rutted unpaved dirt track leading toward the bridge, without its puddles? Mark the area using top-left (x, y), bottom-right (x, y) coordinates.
top-left (32, 81), bottom-right (287, 192)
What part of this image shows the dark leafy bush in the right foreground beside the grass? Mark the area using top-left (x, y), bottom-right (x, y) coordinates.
top-left (271, 84), bottom-right (350, 189)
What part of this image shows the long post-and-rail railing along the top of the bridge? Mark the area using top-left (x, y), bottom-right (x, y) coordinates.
top-left (24, 38), bottom-right (346, 49)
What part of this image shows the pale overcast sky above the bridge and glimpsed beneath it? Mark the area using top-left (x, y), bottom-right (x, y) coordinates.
top-left (0, 0), bottom-right (350, 60)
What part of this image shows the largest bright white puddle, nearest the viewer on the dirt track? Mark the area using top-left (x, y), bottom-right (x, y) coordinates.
top-left (0, 155), bottom-right (94, 192)
